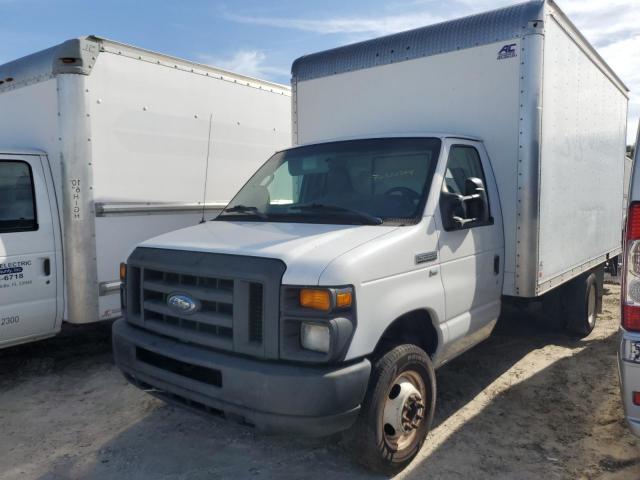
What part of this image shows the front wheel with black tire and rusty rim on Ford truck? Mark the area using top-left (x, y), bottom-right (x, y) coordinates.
top-left (346, 345), bottom-right (436, 474)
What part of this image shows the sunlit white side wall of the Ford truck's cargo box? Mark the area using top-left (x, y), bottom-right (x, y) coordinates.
top-left (529, 15), bottom-right (627, 294)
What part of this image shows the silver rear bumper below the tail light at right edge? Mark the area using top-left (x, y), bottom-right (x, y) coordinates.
top-left (618, 329), bottom-right (640, 437)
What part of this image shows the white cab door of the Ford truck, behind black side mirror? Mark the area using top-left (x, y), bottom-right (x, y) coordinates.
top-left (436, 139), bottom-right (504, 357)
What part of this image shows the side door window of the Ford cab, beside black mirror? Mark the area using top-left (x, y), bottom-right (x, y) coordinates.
top-left (440, 145), bottom-right (492, 230)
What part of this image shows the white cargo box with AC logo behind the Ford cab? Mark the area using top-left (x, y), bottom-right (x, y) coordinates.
top-left (292, 1), bottom-right (628, 297)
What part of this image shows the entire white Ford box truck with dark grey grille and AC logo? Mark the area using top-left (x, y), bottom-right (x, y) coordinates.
top-left (113, 1), bottom-right (627, 471)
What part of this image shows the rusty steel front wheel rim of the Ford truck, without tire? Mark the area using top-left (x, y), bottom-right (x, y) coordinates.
top-left (382, 371), bottom-right (426, 451)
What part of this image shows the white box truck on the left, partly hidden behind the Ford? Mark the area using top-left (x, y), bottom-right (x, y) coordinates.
top-left (0, 37), bottom-right (291, 347)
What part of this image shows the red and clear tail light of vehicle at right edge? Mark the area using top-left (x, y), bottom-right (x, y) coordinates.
top-left (620, 202), bottom-right (640, 332)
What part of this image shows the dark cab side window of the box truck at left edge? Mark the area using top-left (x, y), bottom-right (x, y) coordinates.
top-left (0, 160), bottom-right (38, 233)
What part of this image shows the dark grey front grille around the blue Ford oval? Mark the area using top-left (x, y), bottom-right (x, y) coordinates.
top-left (126, 248), bottom-right (285, 358)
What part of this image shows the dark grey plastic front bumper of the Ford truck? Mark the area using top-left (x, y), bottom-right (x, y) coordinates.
top-left (113, 319), bottom-right (371, 436)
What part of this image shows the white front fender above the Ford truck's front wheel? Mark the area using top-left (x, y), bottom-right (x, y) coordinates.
top-left (319, 217), bottom-right (447, 364)
